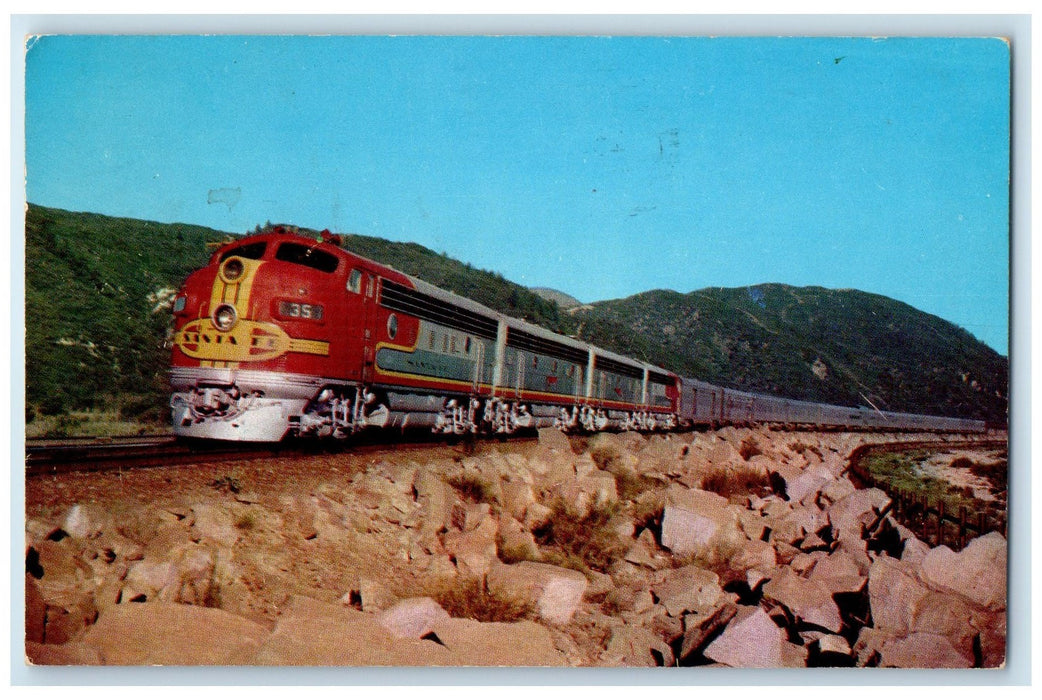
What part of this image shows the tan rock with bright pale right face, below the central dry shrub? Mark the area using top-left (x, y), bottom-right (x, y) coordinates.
top-left (488, 561), bottom-right (588, 625)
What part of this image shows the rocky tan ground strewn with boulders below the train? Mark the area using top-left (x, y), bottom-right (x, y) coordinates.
top-left (25, 428), bottom-right (1007, 668)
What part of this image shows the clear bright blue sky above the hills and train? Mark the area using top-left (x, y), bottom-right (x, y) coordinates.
top-left (26, 35), bottom-right (1010, 354)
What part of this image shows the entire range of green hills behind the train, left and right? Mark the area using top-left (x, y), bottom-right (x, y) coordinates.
top-left (25, 204), bottom-right (1009, 421)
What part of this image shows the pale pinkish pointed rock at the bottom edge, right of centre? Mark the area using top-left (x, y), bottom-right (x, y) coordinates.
top-left (704, 605), bottom-right (807, 669)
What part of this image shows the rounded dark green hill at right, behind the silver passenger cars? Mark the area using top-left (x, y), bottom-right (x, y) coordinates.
top-left (574, 284), bottom-right (1009, 422)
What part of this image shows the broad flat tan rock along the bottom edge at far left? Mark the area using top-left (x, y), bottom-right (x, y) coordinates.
top-left (83, 602), bottom-right (268, 666)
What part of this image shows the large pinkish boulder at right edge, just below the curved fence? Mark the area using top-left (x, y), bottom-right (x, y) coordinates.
top-left (922, 532), bottom-right (1007, 610)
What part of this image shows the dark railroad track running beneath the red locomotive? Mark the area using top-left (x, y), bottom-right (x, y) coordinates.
top-left (25, 432), bottom-right (536, 478)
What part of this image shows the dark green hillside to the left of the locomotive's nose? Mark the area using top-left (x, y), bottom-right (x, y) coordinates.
top-left (25, 205), bottom-right (226, 416)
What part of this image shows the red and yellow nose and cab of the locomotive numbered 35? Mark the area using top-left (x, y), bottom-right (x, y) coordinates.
top-left (171, 229), bottom-right (398, 442)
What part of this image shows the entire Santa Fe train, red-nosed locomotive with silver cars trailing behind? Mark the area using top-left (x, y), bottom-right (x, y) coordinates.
top-left (170, 226), bottom-right (985, 443)
